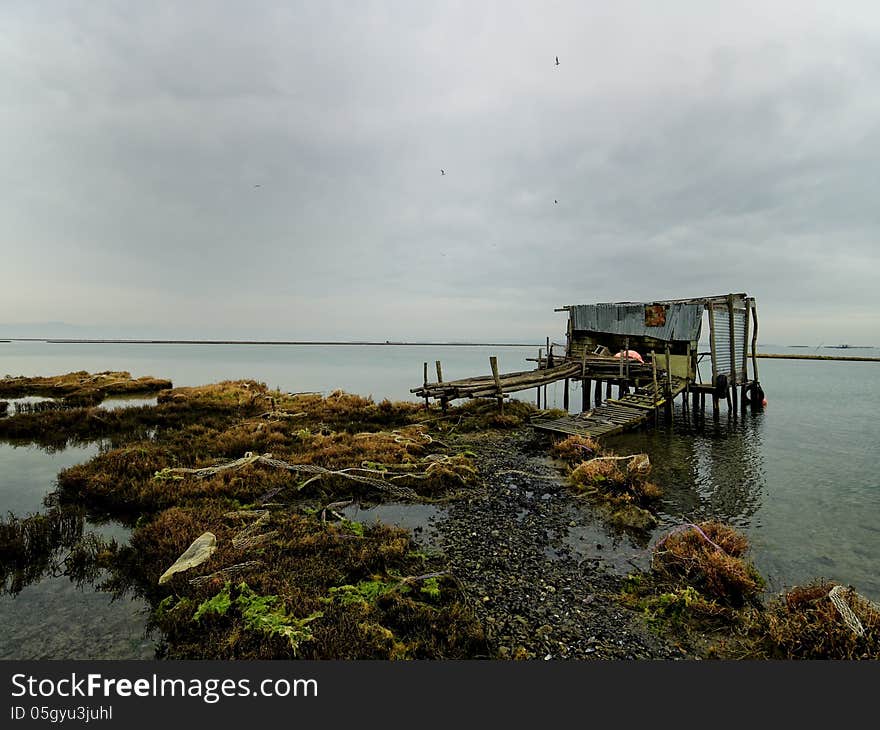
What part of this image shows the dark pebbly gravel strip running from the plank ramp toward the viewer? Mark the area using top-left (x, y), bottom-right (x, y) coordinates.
top-left (432, 427), bottom-right (693, 660)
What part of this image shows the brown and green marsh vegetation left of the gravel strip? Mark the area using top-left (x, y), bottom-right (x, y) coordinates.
top-left (12, 380), bottom-right (496, 659)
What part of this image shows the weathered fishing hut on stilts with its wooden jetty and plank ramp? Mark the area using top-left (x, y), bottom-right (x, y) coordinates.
top-left (411, 294), bottom-right (764, 437)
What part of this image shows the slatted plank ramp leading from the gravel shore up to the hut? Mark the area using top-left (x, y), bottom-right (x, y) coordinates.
top-left (531, 377), bottom-right (687, 438)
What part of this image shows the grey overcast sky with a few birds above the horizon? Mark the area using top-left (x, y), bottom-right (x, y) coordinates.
top-left (0, 0), bottom-right (880, 346)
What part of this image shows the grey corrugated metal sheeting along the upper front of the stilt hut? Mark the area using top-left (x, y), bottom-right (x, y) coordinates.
top-left (569, 303), bottom-right (703, 342)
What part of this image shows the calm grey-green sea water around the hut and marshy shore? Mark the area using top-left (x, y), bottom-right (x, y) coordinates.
top-left (0, 341), bottom-right (880, 659)
